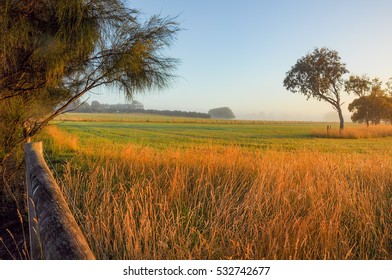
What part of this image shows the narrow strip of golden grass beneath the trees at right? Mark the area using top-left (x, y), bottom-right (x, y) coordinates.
top-left (312, 125), bottom-right (392, 139)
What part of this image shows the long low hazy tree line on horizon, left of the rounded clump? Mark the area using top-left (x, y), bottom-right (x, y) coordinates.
top-left (71, 100), bottom-right (211, 119)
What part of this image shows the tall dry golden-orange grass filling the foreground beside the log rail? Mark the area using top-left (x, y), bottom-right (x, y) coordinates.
top-left (53, 143), bottom-right (392, 259)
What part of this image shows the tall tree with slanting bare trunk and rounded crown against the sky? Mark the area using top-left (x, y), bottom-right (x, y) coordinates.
top-left (283, 48), bottom-right (348, 129)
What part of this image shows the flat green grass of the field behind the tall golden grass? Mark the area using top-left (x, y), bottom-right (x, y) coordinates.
top-left (55, 114), bottom-right (392, 153)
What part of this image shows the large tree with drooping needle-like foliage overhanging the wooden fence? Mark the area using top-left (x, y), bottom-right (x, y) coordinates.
top-left (0, 0), bottom-right (179, 158)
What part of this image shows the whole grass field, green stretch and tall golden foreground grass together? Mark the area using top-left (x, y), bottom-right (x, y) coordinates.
top-left (44, 114), bottom-right (392, 259)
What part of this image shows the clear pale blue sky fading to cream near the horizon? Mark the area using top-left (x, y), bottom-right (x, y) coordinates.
top-left (89, 0), bottom-right (392, 121)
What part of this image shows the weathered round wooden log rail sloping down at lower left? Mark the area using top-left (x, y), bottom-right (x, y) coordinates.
top-left (24, 142), bottom-right (95, 260)
